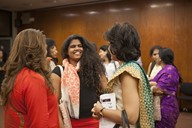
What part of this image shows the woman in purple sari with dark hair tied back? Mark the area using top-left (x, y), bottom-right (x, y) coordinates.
top-left (150, 48), bottom-right (181, 128)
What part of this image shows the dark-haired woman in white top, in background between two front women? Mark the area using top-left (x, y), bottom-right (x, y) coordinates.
top-left (99, 45), bottom-right (119, 80)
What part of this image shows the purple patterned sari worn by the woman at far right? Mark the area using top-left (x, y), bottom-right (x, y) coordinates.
top-left (152, 65), bottom-right (180, 128)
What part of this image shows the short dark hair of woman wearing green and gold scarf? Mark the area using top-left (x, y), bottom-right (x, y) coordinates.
top-left (104, 23), bottom-right (141, 62)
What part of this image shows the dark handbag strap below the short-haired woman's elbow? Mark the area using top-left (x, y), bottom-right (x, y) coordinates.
top-left (113, 110), bottom-right (130, 128)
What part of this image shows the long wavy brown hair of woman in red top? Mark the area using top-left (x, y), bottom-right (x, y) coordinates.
top-left (1, 29), bottom-right (53, 105)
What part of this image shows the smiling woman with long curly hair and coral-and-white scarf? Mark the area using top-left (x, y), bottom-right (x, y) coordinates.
top-left (52, 35), bottom-right (107, 128)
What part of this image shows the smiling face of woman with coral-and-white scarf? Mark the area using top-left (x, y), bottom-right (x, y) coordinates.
top-left (68, 39), bottom-right (83, 63)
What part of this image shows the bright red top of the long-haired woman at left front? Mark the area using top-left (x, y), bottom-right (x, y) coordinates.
top-left (4, 68), bottom-right (58, 128)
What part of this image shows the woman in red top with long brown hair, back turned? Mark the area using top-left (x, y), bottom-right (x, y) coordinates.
top-left (1, 29), bottom-right (59, 128)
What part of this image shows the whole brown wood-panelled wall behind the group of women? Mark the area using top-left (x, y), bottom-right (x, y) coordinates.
top-left (18, 0), bottom-right (192, 82)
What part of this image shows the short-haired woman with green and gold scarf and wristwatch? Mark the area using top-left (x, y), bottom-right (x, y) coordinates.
top-left (92, 23), bottom-right (154, 128)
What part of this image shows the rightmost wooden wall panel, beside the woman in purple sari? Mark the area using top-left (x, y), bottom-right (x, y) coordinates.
top-left (175, 1), bottom-right (192, 82)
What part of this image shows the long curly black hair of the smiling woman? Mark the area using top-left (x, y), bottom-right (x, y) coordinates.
top-left (61, 35), bottom-right (105, 87)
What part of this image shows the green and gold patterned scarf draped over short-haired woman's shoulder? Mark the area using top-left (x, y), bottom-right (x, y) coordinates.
top-left (106, 61), bottom-right (155, 128)
